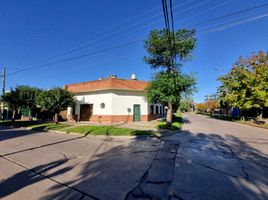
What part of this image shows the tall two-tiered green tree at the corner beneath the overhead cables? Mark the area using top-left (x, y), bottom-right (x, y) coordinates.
top-left (144, 29), bottom-right (196, 126)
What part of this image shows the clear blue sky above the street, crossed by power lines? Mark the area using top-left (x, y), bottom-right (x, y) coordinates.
top-left (0, 0), bottom-right (268, 102)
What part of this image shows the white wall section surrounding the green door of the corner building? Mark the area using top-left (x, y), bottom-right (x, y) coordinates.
top-left (112, 90), bottom-right (149, 115)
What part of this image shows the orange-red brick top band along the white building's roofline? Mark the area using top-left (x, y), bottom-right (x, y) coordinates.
top-left (64, 78), bottom-right (148, 93)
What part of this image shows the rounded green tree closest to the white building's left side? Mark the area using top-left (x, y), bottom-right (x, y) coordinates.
top-left (37, 88), bottom-right (75, 123)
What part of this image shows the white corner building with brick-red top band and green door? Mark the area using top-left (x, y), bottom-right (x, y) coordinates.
top-left (65, 74), bottom-right (165, 123)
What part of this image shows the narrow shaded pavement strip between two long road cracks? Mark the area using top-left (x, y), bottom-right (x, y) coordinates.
top-left (125, 137), bottom-right (180, 200)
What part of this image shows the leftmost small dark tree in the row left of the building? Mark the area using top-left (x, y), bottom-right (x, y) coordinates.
top-left (2, 90), bottom-right (22, 122)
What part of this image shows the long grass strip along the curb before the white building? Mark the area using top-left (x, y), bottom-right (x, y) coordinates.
top-left (0, 121), bottom-right (159, 136)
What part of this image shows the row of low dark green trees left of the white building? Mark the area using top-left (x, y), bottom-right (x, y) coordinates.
top-left (1, 86), bottom-right (75, 123)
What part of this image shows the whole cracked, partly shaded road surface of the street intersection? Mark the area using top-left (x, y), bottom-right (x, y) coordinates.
top-left (0, 114), bottom-right (268, 200)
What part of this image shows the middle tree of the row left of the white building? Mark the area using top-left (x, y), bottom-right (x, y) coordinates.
top-left (16, 86), bottom-right (42, 120)
